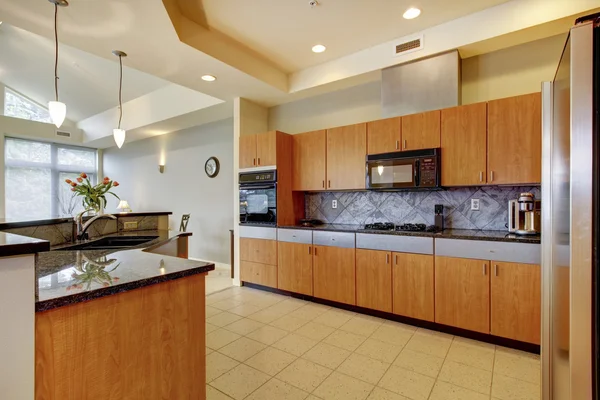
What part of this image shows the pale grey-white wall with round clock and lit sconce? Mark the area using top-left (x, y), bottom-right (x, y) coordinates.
top-left (103, 119), bottom-right (234, 264)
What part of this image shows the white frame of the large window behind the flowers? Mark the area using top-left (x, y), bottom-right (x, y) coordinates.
top-left (2, 136), bottom-right (98, 218)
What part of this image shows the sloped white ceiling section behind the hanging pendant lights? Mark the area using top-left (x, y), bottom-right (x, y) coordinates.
top-left (0, 23), bottom-right (169, 122)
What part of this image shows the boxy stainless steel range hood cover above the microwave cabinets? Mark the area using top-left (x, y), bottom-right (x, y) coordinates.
top-left (381, 50), bottom-right (461, 118)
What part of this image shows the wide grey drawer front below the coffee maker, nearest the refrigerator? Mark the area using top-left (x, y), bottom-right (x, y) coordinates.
top-left (435, 239), bottom-right (541, 264)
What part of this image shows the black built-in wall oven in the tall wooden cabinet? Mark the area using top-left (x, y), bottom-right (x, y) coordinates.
top-left (240, 170), bottom-right (277, 226)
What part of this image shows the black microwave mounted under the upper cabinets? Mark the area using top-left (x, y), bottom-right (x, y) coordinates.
top-left (366, 149), bottom-right (441, 189)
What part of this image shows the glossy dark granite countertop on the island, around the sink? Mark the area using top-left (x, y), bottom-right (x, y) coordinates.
top-left (35, 230), bottom-right (215, 312)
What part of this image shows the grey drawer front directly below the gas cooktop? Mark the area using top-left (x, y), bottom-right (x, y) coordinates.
top-left (356, 233), bottom-right (433, 254)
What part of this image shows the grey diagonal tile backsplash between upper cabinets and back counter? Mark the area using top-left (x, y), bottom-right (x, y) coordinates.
top-left (305, 186), bottom-right (541, 231)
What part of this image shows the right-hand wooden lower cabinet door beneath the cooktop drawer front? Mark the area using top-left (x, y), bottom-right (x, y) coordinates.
top-left (392, 253), bottom-right (434, 322)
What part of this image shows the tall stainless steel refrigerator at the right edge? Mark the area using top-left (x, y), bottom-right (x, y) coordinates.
top-left (541, 14), bottom-right (600, 400)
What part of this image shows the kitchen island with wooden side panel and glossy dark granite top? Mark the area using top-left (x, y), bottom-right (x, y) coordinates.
top-left (35, 230), bottom-right (214, 400)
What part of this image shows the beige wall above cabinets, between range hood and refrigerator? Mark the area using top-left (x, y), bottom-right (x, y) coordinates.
top-left (462, 34), bottom-right (567, 104)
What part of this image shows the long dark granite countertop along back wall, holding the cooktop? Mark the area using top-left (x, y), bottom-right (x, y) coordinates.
top-left (278, 224), bottom-right (541, 243)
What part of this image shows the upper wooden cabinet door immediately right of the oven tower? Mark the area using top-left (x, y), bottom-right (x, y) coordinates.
top-left (292, 130), bottom-right (327, 191)
